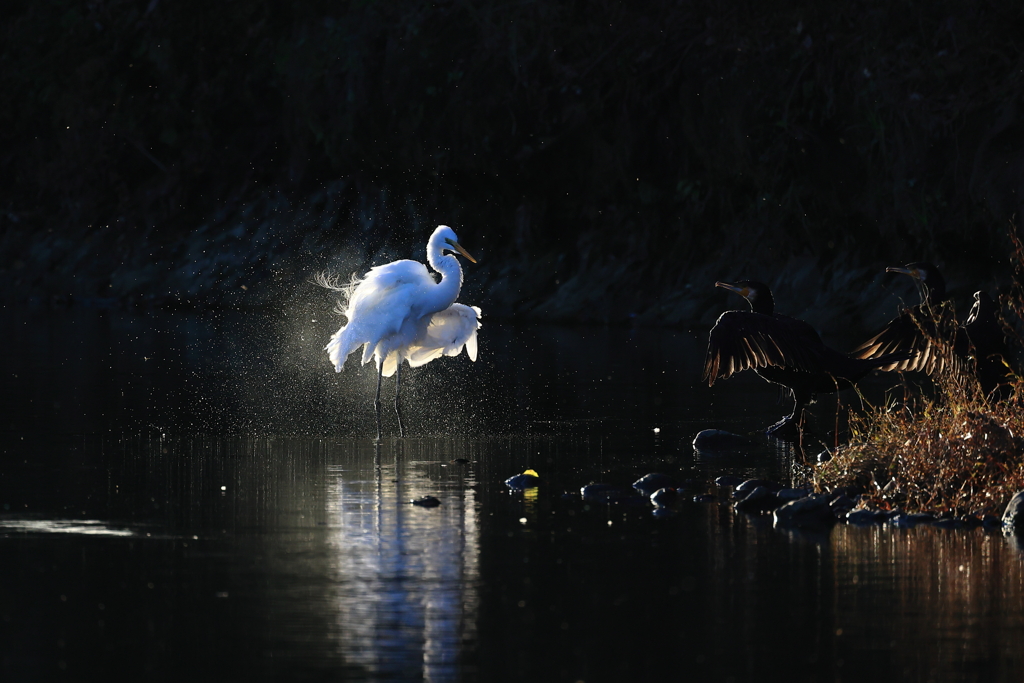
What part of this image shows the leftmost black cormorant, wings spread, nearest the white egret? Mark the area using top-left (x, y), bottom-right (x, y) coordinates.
top-left (702, 280), bottom-right (912, 437)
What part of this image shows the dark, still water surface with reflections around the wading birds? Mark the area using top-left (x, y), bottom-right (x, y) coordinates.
top-left (0, 309), bottom-right (1024, 681)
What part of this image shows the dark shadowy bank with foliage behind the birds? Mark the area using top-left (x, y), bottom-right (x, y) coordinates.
top-left (0, 0), bottom-right (1024, 326)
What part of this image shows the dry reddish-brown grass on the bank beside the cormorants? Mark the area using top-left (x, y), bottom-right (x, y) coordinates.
top-left (813, 229), bottom-right (1024, 514)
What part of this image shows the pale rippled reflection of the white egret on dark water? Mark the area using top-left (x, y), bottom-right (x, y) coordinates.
top-left (327, 441), bottom-right (479, 681)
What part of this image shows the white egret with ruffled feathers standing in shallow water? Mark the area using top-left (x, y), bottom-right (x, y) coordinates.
top-left (319, 225), bottom-right (480, 439)
